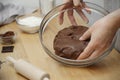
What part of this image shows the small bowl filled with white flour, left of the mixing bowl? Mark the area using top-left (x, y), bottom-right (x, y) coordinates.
top-left (16, 16), bottom-right (42, 33)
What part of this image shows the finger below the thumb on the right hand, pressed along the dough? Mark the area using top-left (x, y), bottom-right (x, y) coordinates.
top-left (77, 42), bottom-right (95, 60)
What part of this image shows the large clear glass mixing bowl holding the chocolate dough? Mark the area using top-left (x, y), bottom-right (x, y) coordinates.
top-left (39, 2), bottom-right (115, 67)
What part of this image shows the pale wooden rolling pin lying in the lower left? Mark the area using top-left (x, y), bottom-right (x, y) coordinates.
top-left (6, 56), bottom-right (50, 80)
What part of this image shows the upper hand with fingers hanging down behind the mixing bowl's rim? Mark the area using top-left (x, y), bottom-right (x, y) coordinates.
top-left (59, 0), bottom-right (90, 25)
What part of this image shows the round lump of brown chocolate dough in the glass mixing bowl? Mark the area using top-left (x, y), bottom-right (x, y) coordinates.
top-left (53, 26), bottom-right (90, 59)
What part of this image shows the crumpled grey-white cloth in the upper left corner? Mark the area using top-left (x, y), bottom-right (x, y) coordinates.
top-left (0, 2), bottom-right (36, 26)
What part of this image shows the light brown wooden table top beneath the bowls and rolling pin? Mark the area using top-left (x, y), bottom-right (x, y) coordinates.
top-left (0, 13), bottom-right (120, 80)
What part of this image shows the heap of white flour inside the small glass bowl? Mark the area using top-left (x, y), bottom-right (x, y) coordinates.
top-left (18, 16), bottom-right (42, 27)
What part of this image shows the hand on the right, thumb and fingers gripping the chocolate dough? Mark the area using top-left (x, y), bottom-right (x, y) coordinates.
top-left (78, 17), bottom-right (118, 59)
